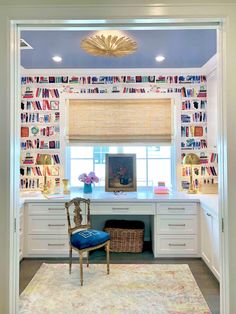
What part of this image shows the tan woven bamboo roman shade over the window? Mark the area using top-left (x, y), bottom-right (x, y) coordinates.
top-left (66, 99), bottom-right (172, 143)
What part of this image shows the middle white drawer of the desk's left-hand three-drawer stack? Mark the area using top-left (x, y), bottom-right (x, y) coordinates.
top-left (28, 216), bottom-right (68, 235)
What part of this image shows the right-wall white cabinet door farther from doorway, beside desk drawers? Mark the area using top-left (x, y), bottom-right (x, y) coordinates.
top-left (201, 209), bottom-right (212, 267)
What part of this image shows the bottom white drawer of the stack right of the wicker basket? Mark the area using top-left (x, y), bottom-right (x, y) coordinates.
top-left (157, 235), bottom-right (198, 256)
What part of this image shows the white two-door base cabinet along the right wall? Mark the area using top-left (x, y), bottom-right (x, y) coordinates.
top-left (201, 208), bottom-right (220, 280)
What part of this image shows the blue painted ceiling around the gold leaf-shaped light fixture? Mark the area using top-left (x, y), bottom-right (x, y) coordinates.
top-left (21, 29), bottom-right (216, 69)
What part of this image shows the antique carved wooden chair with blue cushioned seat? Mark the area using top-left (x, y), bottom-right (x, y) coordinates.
top-left (65, 197), bottom-right (110, 286)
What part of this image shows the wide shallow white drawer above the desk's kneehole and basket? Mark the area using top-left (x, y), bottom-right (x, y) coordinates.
top-left (91, 202), bottom-right (155, 215)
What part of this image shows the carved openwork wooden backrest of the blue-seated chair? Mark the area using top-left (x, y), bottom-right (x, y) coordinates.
top-left (65, 197), bottom-right (91, 235)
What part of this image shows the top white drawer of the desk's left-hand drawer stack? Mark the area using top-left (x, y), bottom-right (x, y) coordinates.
top-left (28, 203), bottom-right (66, 217)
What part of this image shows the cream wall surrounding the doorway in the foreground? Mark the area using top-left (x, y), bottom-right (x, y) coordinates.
top-left (0, 0), bottom-right (236, 314)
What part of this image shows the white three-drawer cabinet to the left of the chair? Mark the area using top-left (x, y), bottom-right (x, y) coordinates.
top-left (25, 202), bottom-right (69, 257)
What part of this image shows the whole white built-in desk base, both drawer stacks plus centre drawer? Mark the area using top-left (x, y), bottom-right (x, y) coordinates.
top-left (25, 201), bottom-right (199, 257)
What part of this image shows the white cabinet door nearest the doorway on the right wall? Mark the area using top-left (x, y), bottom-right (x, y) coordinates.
top-left (212, 217), bottom-right (220, 280)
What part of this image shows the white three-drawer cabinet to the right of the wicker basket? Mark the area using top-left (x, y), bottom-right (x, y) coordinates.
top-left (153, 202), bottom-right (199, 257)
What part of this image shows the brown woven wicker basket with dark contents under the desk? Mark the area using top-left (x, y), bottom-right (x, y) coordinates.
top-left (104, 220), bottom-right (144, 253)
